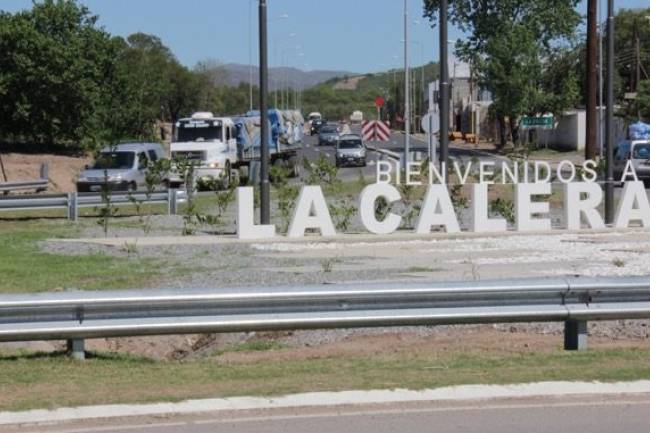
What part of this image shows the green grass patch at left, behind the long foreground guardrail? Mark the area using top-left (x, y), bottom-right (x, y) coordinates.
top-left (0, 220), bottom-right (170, 293)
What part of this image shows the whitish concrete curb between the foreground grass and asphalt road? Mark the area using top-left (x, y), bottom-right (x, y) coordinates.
top-left (0, 380), bottom-right (650, 425)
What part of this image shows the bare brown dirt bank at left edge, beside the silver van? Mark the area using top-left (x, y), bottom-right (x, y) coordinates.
top-left (0, 153), bottom-right (91, 192)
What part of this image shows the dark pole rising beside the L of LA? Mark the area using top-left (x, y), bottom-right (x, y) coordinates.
top-left (259, 0), bottom-right (271, 224)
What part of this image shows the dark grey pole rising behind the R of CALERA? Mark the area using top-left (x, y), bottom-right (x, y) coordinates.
top-left (605, 0), bottom-right (614, 224)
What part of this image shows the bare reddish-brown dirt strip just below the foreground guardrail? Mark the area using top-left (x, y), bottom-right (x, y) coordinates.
top-left (53, 325), bottom-right (650, 364)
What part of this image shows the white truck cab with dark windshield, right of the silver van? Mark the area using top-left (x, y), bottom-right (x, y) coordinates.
top-left (169, 112), bottom-right (237, 187)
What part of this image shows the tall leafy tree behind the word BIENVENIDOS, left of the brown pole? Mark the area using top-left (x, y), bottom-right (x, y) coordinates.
top-left (424, 0), bottom-right (580, 145)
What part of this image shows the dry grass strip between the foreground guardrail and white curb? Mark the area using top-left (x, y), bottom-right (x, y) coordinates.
top-left (0, 343), bottom-right (650, 410)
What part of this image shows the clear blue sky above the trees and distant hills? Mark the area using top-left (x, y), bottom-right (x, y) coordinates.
top-left (0, 0), bottom-right (648, 72)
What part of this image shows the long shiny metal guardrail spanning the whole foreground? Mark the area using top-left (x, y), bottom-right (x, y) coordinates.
top-left (0, 277), bottom-right (650, 355)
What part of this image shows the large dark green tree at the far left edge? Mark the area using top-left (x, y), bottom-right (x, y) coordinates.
top-left (0, 0), bottom-right (115, 147)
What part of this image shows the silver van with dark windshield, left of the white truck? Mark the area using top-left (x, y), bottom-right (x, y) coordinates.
top-left (77, 143), bottom-right (165, 192)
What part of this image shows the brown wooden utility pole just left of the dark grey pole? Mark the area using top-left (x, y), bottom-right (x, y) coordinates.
top-left (584, 0), bottom-right (598, 159)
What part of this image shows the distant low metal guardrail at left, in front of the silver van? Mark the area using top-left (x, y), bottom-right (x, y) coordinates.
top-left (0, 189), bottom-right (186, 221)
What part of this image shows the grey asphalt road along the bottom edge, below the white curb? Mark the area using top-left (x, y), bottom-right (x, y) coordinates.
top-left (13, 396), bottom-right (650, 433)
